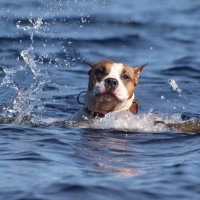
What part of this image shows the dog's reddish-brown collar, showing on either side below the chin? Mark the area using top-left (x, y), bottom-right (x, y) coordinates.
top-left (85, 99), bottom-right (139, 118)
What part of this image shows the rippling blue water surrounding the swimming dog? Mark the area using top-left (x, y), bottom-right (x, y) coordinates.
top-left (0, 0), bottom-right (200, 200)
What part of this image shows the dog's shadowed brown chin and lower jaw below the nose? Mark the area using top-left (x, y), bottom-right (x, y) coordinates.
top-left (95, 92), bottom-right (120, 112)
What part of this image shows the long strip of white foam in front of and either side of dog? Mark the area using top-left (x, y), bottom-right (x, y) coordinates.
top-left (39, 111), bottom-right (195, 133)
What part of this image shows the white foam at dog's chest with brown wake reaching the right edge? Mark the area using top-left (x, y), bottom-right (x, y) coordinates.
top-left (80, 111), bottom-right (200, 133)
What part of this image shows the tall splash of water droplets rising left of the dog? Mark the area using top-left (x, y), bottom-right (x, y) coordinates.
top-left (3, 14), bottom-right (46, 123)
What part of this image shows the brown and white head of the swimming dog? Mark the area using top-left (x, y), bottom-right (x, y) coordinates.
top-left (86, 61), bottom-right (145, 114)
